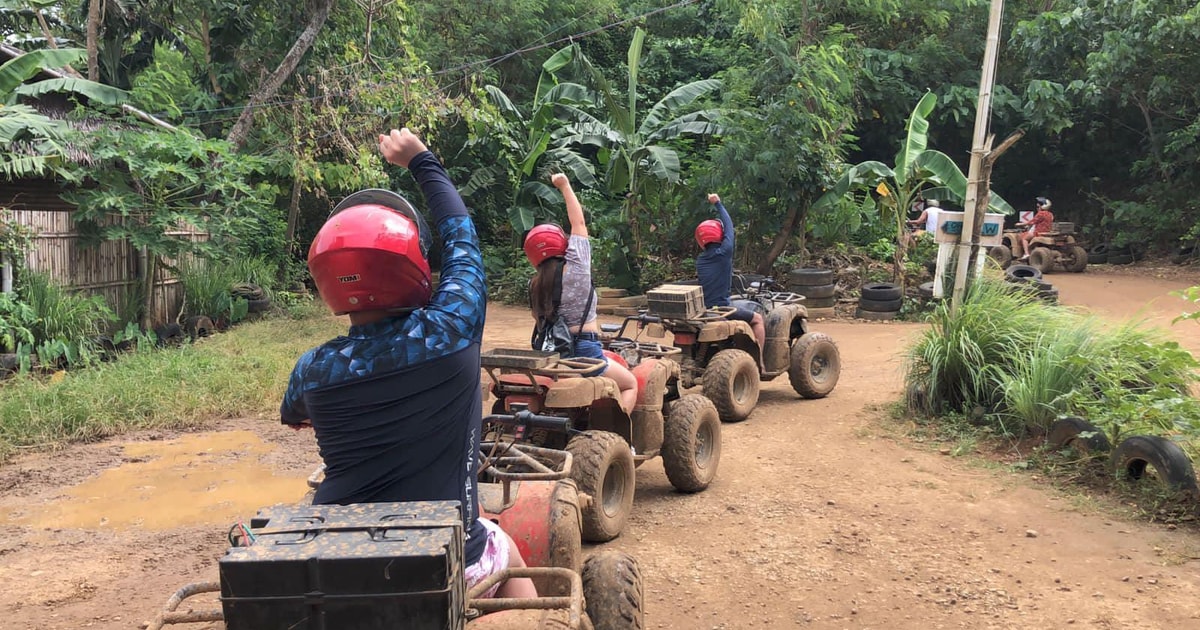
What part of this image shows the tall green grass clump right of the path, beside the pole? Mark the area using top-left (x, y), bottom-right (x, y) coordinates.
top-left (906, 281), bottom-right (1200, 448)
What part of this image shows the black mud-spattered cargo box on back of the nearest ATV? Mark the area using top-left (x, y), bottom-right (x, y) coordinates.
top-left (220, 502), bottom-right (466, 630)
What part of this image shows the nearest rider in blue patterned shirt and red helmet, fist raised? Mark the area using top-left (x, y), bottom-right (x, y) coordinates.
top-left (280, 128), bottom-right (536, 598)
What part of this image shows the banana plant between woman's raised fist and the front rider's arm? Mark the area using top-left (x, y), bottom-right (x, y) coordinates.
top-left (554, 28), bottom-right (721, 258)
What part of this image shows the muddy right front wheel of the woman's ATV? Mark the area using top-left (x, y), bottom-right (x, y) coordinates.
top-left (662, 394), bottom-right (721, 492)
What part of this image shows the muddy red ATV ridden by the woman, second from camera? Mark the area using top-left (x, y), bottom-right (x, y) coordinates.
top-left (481, 344), bottom-right (721, 542)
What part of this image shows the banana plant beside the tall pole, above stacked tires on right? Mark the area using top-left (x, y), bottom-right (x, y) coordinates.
top-left (810, 92), bottom-right (1014, 278)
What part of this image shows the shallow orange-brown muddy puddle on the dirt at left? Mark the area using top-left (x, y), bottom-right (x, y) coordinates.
top-left (8, 431), bottom-right (307, 529)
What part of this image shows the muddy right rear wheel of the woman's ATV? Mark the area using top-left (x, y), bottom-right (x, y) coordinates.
top-left (566, 431), bottom-right (636, 542)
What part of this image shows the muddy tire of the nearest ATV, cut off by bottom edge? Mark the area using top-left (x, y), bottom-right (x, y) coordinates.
top-left (581, 551), bottom-right (646, 630)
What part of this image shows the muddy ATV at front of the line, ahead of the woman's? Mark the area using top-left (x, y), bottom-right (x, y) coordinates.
top-left (623, 286), bottom-right (841, 422)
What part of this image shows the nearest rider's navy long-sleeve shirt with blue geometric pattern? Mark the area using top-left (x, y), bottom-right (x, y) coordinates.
top-left (280, 151), bottom-right (487, 564)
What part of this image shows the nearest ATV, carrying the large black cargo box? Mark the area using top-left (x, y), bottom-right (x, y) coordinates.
top-left (146, 429), bottom-right (643, 630)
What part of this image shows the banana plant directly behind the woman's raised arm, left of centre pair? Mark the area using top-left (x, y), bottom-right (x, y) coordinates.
top-left (461, 49), bottom-right (596, 234)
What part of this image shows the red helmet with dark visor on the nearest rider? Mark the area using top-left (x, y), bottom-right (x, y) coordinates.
top-left (308, 190), bottom-right (432, 314)
